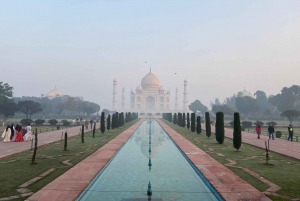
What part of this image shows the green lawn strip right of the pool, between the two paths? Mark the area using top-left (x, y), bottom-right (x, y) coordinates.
top-left (163, 120), bottom-right (300, 198)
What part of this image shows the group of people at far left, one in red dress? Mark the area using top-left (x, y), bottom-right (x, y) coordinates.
top-left (2, 124), bottom-right (32, 142)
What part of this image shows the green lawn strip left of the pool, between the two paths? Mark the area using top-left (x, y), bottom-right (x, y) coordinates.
top-left (0, 120), bottom-right (137, 200)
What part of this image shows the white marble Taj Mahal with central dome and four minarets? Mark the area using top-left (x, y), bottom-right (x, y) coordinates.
top-left (113, 69), bottom-right (189, 113)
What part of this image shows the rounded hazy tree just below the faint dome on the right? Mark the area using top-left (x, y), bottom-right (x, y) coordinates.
top-left (235, 96), bottom-right (260, 115)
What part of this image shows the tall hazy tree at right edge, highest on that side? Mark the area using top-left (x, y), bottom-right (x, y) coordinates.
top-left (269, 85), bottom-right (300, 112)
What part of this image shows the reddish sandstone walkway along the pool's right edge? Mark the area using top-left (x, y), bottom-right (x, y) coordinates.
top-left (157, 119), bottom-right (271, 201)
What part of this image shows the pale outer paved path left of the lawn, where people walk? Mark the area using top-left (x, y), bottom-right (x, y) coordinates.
top-left (0, 124), bottom-right (99, 159)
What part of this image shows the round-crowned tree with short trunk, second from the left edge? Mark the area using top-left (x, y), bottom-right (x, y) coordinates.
top-left (17, 100), bottom-right (43, 119)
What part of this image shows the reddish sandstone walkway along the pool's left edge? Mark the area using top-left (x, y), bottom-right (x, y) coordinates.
top-left (26, 119), bottom-right (144, 201)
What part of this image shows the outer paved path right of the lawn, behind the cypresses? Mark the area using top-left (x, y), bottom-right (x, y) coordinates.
top-left (202, 124), bottom-right (300, 160)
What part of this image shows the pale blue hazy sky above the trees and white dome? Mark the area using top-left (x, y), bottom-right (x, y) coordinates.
top-left (0, 0), bottom-right (300, 109)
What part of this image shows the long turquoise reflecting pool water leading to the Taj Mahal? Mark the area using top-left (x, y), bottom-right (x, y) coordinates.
top-left (77, 119), bottom-right (221, 201)
